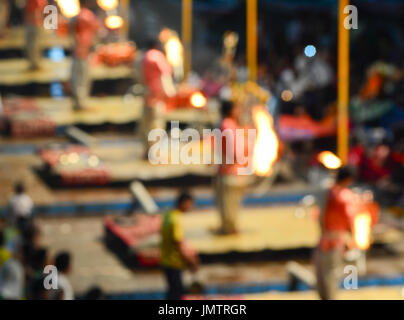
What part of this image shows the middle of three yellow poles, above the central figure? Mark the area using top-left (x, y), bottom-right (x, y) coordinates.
top-left (246, 0), bottom-right (258, 82)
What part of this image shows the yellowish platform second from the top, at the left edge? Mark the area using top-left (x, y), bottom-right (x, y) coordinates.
top-left (0, 58), bottom-right (132, 86)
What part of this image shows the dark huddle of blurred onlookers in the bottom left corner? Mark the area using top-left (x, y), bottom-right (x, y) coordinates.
top-left (0, 183), bottom-right (105, 300)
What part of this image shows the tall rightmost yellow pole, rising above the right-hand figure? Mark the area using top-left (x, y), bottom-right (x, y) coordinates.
top-left (337, 0), bottom-right (349, 164)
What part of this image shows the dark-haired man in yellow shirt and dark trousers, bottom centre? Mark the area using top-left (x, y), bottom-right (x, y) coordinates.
top-left (161, 193), bottom-right (199, 300)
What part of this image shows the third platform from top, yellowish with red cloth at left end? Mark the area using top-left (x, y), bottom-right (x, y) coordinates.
top-left (3, 96), bottom-right (219, 138)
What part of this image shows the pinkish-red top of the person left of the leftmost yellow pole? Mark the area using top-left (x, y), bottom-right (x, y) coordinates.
top-left (143, 49), bottom-right (173, 107)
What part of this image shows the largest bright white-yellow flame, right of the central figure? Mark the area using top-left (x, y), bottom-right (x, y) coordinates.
top-left (252, 106), bottom-right (279, 176)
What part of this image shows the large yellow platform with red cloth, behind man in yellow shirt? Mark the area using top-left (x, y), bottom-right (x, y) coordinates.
top-left (105, 206), bottom-right (403, 267)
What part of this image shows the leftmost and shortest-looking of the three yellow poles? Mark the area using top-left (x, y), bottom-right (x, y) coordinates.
top-left (182, 0), bottom-right (192, 77)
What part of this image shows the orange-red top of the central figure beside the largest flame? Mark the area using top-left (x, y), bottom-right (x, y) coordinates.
top-left (219, 118), bottom-right (248, 175)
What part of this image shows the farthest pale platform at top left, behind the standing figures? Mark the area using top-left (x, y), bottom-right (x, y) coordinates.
top-left (0, 27), bottom-right (73, 50)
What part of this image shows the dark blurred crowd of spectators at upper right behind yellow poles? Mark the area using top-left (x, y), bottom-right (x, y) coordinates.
top-left (203, 8), bottom-right (404, 207)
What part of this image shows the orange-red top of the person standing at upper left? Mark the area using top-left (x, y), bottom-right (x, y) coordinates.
top-left (73, 8), bottom-right (99, 59)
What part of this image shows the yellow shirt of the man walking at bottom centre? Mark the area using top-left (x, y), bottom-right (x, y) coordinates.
top-left (161, 209), bottom-right (186, 269)
